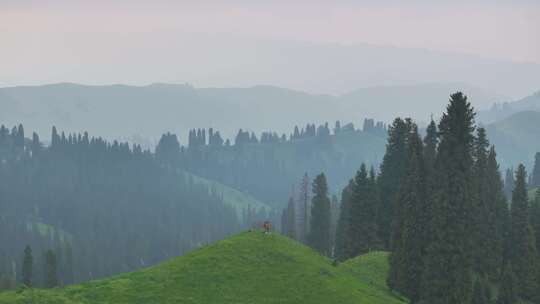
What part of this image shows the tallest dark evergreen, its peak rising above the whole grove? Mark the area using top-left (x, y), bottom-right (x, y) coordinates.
top-left (421, 92), bottom-right (475, 304)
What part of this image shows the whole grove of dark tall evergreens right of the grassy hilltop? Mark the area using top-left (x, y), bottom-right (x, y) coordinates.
top-left (282, 92), bottom-right (540, 304)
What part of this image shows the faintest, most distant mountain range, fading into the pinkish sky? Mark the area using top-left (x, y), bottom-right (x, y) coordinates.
top-left (5, 33), bottom-right (540, 99)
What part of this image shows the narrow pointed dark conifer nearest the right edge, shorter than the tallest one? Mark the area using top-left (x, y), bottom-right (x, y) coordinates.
top-left (510, 164), bottom-right (537, 299)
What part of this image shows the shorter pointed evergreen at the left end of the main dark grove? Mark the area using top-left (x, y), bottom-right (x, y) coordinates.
top-left (345, 164), bottom-right (382, 257)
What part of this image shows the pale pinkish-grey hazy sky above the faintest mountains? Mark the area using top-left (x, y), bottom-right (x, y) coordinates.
top-left (0, 0), bottom-right (540, 90)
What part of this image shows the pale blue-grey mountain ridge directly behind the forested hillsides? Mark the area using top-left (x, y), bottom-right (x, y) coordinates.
top-left (0, 83), bottom-right (501, 143)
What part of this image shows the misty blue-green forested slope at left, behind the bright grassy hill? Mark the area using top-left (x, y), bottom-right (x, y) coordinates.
top-left (0, 125), bottom-right (268, 288)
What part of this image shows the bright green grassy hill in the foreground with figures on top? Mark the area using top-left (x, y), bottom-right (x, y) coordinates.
top-left (0, 232), bottom-right (405, 304)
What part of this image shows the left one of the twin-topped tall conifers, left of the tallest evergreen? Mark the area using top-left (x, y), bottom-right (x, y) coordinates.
top-left (377, 118), bottom-right (411, 248)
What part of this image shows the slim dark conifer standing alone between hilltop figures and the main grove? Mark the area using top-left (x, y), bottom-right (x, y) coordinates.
top-left (308, 173), bottom-right (331, 256)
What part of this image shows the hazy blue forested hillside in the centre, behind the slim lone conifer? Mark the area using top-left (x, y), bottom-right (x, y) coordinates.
top-left (174, 120), bottom-right (386, 208)
